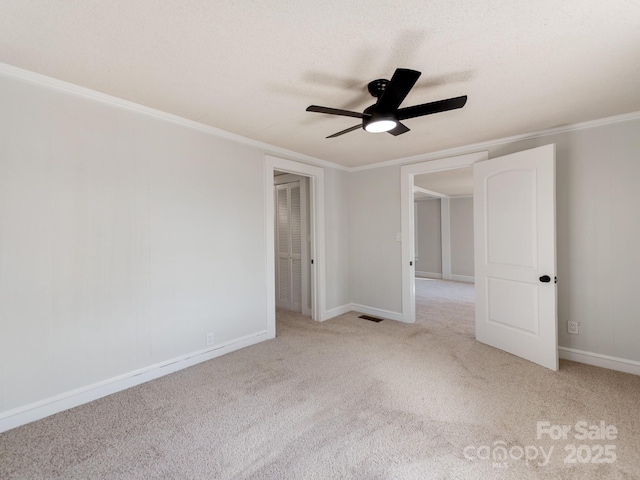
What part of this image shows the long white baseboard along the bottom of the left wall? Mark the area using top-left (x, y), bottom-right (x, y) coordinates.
top-left (0, 331), bottom-right (269, 433)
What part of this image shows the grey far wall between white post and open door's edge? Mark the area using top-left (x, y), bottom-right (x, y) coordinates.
top-left (449, 197), bottom-right (474, 279)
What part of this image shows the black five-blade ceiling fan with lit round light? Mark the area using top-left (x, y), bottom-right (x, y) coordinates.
top-left (307, 68), bottom-right (467, 138)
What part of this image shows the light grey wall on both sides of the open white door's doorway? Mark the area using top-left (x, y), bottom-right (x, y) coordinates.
top-left (351, 119), bottom-right (640, 362)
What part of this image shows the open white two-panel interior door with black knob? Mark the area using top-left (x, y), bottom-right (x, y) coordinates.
top-left (474, 145), bottom-right (558, 370)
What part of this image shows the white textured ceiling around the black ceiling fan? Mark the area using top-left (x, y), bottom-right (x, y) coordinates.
top-left (0, 0), bottom-right (640, 167)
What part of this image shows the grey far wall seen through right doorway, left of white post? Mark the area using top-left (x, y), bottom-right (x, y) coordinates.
top-left (414, 198), bottom-right (442, 278)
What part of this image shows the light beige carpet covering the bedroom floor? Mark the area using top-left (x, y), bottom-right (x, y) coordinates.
top-left (0, 280), bottom-right (640, 480)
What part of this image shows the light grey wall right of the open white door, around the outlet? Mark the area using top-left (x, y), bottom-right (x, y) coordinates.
top-left (490, 120), bottom-right (640, 362)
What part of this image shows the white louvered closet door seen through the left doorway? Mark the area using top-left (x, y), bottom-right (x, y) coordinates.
top-left (276, 182), bottom-right (302, 312)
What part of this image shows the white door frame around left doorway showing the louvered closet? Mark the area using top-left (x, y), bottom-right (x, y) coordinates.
top-left (264, 155), bottom-right (326, 338)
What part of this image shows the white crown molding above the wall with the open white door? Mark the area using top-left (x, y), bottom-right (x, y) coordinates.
top-left (349, 112), bottom-right (640, 172)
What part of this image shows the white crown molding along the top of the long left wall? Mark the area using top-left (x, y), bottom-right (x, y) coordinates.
top-left (0, 62), bottom-right (349, 171)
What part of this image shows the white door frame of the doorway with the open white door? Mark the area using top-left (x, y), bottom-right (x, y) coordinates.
top-left (400, 151), bottom-right (489, 323)
